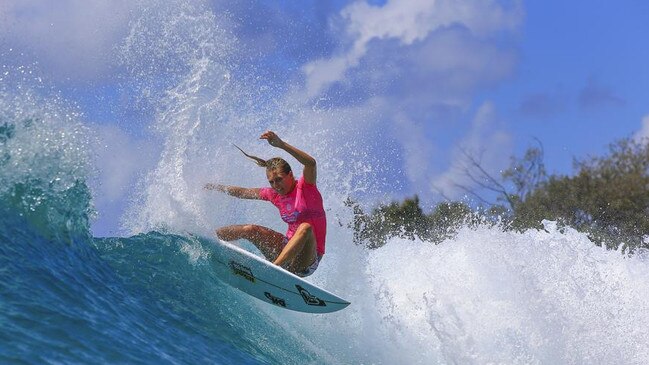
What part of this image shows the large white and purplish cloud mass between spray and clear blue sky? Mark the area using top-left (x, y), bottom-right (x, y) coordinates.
top-left (289, 0), bottom-right (523, 205)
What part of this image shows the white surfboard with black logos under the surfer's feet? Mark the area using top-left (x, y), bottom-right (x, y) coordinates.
top-left (211, 239), bottom-right (350, 313)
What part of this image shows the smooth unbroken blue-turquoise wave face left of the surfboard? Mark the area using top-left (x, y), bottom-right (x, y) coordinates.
top-left (0, 186), bottom-right (302, 364)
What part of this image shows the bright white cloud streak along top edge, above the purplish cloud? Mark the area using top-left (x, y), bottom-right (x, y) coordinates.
top-left (303, 0), bottom-right (522, 98)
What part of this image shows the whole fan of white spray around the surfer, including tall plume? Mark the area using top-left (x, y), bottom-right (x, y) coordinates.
top-left (120, 1), bottom-right (394, 234)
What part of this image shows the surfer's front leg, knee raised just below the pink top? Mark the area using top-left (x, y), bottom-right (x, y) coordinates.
top-left (274, 223), bottom-right (316, 272)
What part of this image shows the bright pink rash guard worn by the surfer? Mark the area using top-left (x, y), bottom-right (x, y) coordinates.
top-left (259, 177), bottom-right (327, 256)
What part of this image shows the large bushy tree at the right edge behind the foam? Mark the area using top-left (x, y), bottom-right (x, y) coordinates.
top-left (513, 139), bottom-right (649, 250)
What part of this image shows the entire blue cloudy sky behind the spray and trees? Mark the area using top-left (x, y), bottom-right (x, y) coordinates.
top-left (0, 0), bottom-right (649, 235)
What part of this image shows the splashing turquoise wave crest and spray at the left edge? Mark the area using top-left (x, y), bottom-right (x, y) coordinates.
top-left (0, 71), bottom-right (94, 242)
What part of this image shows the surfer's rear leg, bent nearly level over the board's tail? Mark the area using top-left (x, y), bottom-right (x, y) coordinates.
top-left (216, 224), bottom-right (285, 260)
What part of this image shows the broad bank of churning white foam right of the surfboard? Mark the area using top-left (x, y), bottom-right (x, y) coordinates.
top-left (278, 222), bottom-right (649, 364)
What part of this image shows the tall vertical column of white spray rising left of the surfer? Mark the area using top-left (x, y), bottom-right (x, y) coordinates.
top-left (120, 1), bottom-right (248, 233)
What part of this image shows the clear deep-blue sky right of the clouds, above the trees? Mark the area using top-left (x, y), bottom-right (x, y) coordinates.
top-left (492, 1), bottom-right (649, 172)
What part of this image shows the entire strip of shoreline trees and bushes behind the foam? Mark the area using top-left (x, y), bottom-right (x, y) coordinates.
top-left (346, 138), bottom-right (649, 254)
